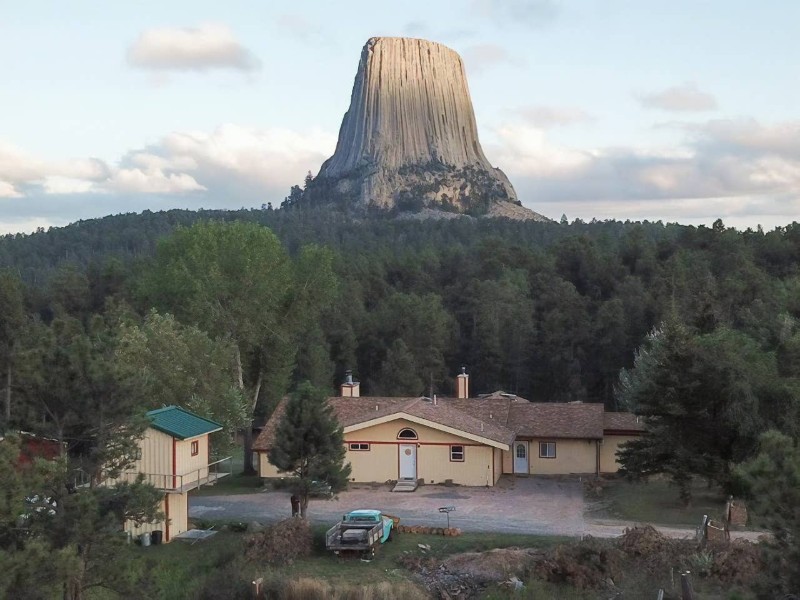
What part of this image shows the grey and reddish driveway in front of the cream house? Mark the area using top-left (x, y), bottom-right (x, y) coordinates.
top-left (189, 477), bottom-right (761, 540)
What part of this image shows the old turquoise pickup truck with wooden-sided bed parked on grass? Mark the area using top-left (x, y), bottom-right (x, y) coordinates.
top-left (325, 509), bottom-right (400, 556)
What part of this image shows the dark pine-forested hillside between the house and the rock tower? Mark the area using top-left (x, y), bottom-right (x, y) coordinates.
top-left (0, 210), bottom-right (800, 408)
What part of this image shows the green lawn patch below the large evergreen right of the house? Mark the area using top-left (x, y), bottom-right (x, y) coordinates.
top-left (586, 479), bottom-right (726, 527)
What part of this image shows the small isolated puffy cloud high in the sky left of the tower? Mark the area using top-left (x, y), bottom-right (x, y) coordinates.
top-left (128, 24), bottom-right (261, 71)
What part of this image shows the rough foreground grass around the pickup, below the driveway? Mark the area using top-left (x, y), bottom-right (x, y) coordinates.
top-left (106, 522), bottom-right (751, 600)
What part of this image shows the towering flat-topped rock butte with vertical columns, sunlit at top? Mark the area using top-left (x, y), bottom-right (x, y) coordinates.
top-left (307, 38), bottom-right (548, 214)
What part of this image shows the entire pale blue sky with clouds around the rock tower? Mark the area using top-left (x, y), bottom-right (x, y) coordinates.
top-left (0, 0), bottom-right (800, 233)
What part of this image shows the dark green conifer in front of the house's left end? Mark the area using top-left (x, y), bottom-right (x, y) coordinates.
top-left (269, 382), bottom-right (350, 518)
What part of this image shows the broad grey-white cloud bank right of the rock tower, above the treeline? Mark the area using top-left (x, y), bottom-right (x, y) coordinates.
top-left (490, 113), bottom-right (800, 226)
